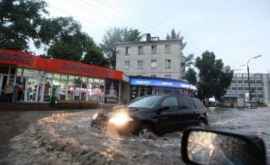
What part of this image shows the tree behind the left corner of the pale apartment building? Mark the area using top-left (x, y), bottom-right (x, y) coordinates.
top-left (101, 28), bottom-right (141, 68)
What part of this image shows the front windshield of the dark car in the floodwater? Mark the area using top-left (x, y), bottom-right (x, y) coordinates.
top-left (128, 96), bottom-right (162, 109)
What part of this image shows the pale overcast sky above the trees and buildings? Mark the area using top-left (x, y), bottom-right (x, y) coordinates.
top-left (43, 0), bottom-right (270, 72)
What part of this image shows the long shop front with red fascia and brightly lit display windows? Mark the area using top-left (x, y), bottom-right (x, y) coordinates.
top-left (0, 50), bottom-right (123, 103)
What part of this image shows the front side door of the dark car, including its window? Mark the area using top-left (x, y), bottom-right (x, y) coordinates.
top-left (158, 96), bottom-right (179, 132)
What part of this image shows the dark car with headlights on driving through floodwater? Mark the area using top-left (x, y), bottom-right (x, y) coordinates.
top-left (91, 95), bottom-right (208, 135)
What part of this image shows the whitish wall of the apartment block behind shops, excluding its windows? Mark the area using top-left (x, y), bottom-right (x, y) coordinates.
top-left (116, 41), bottom-right (183, 79)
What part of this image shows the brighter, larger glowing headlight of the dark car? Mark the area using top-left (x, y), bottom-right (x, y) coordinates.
top-left (109, 111), bottom-right (133, 127)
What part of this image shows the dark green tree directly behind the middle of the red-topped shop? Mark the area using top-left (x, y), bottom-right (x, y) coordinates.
top-left (46, 17), bottom-right (108, 66)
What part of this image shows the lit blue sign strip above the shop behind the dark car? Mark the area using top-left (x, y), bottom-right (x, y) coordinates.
top-left (130, 78), bottom-right (196, 90)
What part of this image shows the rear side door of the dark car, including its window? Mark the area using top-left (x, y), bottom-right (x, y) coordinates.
top-left (177, 96), bottom-right (196, 127)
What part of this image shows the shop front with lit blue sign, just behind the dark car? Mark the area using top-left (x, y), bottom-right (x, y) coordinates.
top-left (129, 76), bottom-right (197, 99)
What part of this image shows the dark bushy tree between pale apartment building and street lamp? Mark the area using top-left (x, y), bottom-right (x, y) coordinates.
top-left (195, 51), bottom-right (233, 100)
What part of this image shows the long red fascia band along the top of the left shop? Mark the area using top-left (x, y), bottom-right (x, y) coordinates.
top-left (0, 50), bottom-right (124, 80)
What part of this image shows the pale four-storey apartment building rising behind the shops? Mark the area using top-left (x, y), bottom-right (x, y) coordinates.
top-left (116, 35), bottom-right (185, 79)
